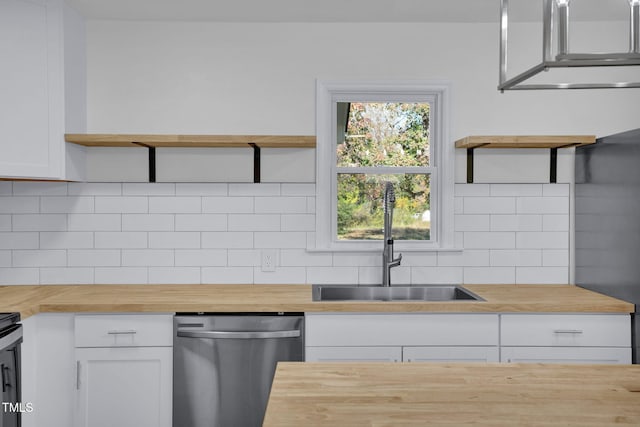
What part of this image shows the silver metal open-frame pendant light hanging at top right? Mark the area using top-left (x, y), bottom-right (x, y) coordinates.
top-left (498, 0), bottom-right (640, 92)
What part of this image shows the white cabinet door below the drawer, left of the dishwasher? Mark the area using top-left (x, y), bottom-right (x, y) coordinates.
top-left (76, 347), bottom-right (173, 427)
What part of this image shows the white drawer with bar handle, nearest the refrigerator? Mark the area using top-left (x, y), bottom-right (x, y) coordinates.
top-left (500, 314), bottom-right (631, 347)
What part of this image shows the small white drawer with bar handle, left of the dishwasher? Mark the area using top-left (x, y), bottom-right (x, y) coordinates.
top-left (75, 314), bottom-right (173, 347)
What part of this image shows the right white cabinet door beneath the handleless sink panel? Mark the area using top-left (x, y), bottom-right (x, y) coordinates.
top-left (402, 347), bottom-right (499, 362)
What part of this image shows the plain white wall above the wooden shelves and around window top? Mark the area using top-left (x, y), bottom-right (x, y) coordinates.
top-left (87, 21), bottom-right (640, 140)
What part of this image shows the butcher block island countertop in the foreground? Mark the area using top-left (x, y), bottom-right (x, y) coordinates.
top-left (263, 362), bottom-right (640, 427)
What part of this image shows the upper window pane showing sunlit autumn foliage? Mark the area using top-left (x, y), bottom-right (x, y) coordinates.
top-left (336, 102), bottom-right (430, 167)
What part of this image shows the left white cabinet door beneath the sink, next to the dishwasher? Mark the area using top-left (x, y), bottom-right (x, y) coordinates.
top-left (305, 347), bottom-right (402, 362)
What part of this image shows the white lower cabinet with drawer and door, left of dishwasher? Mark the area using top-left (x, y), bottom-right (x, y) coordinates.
top-left (75, 314), bottom-right (173, 427)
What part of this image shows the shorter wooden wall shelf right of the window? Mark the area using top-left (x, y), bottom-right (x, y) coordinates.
top-left (456, 135), bottom-right (596, 149)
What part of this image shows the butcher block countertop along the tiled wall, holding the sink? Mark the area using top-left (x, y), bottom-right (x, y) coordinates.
top-left (0, 285), bottom-right (634, 318)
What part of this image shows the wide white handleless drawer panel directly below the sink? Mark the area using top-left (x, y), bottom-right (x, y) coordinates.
top-left (305, 314), bottom-right (498, 346)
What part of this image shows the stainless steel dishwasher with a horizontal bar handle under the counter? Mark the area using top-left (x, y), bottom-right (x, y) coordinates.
top-left (173, 313), bottom-right (304, 427)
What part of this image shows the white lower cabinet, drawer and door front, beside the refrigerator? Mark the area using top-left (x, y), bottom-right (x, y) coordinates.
top-left (500, 314), bottom-right (631, 364)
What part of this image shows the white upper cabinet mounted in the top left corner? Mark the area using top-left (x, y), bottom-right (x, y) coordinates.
top-left (0, 0), bottom-right (86, 179)
